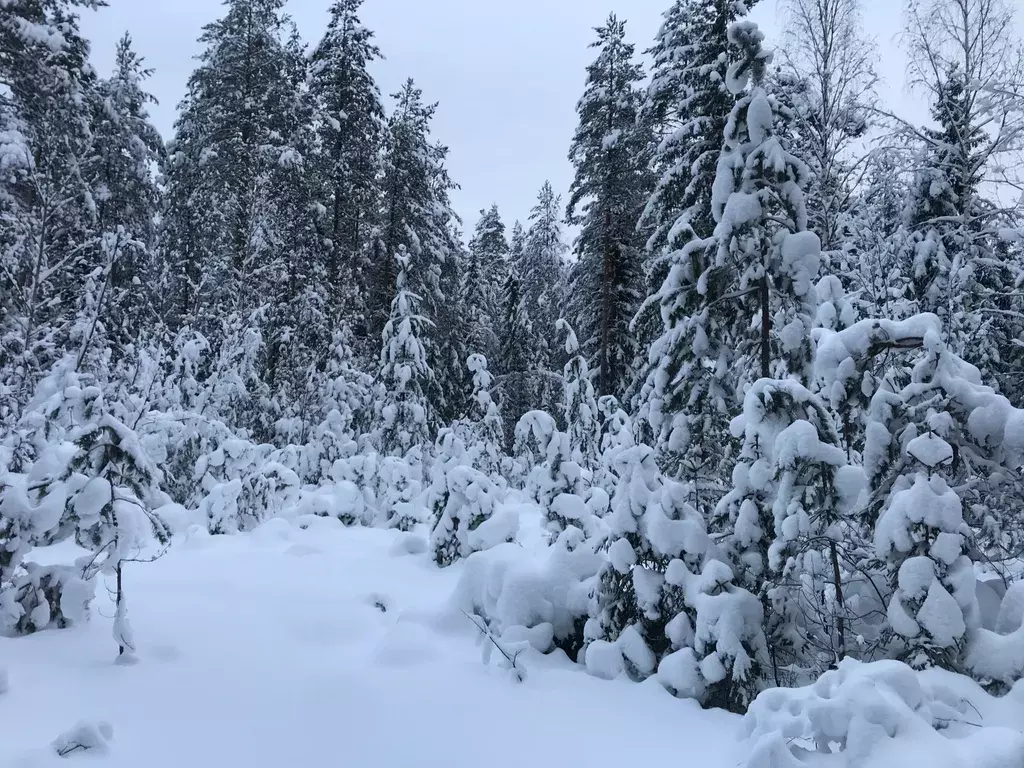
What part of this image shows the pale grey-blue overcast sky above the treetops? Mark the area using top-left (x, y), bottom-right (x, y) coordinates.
top-left (82, 0), bottom-right (926, 240)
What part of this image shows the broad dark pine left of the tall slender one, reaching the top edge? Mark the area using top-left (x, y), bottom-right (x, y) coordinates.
top-left (164, 0), bottom-right (309, 335)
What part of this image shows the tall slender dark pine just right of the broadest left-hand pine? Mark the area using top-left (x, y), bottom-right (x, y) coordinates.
top-left (309, 0), bottom-right (386, 337)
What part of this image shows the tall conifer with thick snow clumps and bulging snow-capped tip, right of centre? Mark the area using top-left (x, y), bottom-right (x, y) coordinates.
top-left (642, 20), bottom-right (820, 504)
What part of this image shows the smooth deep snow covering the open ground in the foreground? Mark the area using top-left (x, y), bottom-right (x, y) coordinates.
top-left (0, 507), bottom-right (1024, 768)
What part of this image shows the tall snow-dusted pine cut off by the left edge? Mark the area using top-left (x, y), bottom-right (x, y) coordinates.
top-left (0, 0), bottom-right (100, 417)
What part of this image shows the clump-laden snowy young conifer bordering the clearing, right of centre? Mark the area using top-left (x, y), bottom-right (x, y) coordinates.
top-left (586, 444), bottom-right (766, 711)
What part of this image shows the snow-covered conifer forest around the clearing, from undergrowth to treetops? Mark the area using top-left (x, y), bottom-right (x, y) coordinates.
top-left (6, 0), bottom-right (1024, 724)
